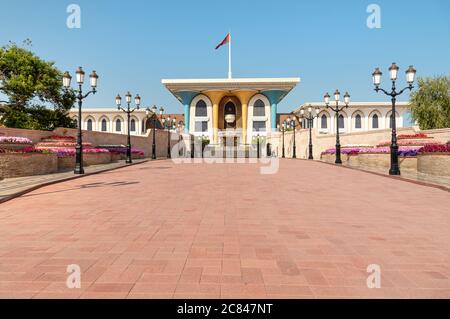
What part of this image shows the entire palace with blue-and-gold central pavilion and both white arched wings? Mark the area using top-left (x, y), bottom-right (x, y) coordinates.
top-left (69, 78), bottom-right (415, 141)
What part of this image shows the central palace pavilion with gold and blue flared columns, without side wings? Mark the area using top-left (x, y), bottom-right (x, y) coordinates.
top-left (162, 78), bottom-right (300, 145)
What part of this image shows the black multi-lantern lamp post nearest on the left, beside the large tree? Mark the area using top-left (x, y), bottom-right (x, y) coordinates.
top-left (63, 66), bottom-right (98, 174)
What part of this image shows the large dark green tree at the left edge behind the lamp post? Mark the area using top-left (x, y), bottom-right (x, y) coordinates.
top-left (0, 41), bottom-right (75, 130)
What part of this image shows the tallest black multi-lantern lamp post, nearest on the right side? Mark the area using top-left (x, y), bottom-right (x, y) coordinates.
top-left (372, 63), bottom-right (416, 175)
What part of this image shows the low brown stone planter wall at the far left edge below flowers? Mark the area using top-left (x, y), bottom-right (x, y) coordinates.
top-left (0, 153), bottom-right (58, 178)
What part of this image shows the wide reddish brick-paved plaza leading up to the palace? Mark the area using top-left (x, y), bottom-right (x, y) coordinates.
top-left (0, 160), bottom-right (450, 298)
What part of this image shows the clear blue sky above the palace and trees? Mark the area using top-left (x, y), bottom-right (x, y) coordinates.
top-left (0, 0), bottom-right (450, 113)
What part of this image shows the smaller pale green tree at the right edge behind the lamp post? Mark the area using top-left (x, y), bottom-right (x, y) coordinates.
top-left (410, 76), bottom-right (450, 130)
